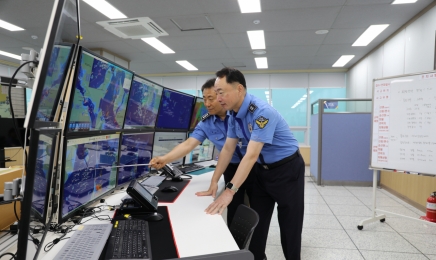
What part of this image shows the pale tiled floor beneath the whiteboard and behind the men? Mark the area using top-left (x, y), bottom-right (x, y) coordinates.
top-left (266, 168), bottom-right (436, 260)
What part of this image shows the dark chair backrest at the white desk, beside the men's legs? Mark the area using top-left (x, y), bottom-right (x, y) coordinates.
top-left (230, 204), bottom-right (259, 249)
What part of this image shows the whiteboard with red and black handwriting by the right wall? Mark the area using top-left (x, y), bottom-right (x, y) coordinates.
top-left (371, 71), bottom-right (436, 175)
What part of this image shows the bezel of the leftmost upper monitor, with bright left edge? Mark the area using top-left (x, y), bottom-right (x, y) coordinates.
top-left (24, 0), bottom-right (81, 128)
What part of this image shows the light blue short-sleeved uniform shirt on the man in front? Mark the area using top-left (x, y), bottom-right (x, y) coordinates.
top-left (227, 93), bottom-right (298, 164)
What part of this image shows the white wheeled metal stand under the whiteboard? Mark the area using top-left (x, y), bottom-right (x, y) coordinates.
top-left (357, 169), bottom-right (436, 230)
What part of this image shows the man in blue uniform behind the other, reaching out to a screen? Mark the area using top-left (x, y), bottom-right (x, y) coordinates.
top-left (150, 78), bottom-right (254, 226)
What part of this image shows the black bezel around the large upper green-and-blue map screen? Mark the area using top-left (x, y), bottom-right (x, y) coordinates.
top-left (64, 46), bottom-right (135, 136)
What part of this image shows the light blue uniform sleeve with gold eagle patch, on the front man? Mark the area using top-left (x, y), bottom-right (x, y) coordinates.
top-left (250, 107), bottom-right (279, 144)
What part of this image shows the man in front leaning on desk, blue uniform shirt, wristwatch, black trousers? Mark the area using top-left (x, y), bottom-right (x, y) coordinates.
top-left (206, 68), bottom-right (305, 260)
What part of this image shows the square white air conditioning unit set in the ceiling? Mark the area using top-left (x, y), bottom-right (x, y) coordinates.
top-left (97, 17), bottom-right (168, 39)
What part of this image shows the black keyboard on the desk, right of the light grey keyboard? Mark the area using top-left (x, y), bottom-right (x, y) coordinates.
top-left (105, 219), bottom-right (152, 259)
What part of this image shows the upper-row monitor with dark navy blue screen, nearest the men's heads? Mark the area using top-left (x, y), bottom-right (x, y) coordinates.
top-left (156, 88), bottom-right (194, 130)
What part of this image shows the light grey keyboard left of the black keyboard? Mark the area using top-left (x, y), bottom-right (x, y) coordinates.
top-left (53, 224), bottom-right (112, 260)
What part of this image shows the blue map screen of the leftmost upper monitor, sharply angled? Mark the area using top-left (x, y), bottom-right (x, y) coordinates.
top-left (36, 45), bottom-right (72, 121)
